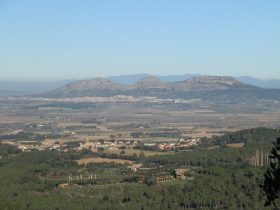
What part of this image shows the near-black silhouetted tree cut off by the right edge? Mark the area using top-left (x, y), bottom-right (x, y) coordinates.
top-left (261, 138), bottom-right (280, 208)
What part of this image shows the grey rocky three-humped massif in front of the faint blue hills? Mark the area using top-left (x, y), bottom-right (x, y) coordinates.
top-left (40, 76), bottom-right (280, 102)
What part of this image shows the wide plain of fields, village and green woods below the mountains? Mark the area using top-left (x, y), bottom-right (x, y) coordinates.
top-left (0, 98), bottom-right (280, 210)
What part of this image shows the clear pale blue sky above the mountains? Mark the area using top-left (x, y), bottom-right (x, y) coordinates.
top-left (0, 0), bottom-right (280, 80)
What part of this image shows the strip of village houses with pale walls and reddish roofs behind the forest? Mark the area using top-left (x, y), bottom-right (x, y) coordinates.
top-left (2, 132), bottom-right (200, 153)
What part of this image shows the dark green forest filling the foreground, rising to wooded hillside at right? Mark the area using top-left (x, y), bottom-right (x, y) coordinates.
top-left (0, 128), bottom-right (279, 210)
